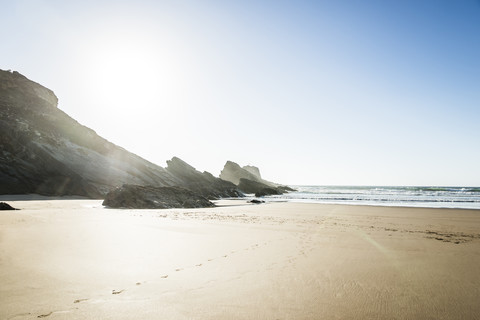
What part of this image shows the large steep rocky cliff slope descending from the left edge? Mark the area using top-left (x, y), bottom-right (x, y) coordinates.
top-left (0, 70), bottom-right (235, 198)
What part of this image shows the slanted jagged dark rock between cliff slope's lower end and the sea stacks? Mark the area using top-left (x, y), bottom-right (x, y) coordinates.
top-left (166, 157), bottom-right (243, 199)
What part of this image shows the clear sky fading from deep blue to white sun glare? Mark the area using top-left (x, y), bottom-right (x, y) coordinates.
top-left (0, 0), bottom-right (480, 186)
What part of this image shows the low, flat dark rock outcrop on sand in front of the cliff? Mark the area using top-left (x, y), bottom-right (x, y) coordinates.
top-left (103, 185), bottom-right (215, 209)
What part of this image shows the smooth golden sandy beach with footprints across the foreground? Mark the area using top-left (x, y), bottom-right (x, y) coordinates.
top-left (0, 199), bottom-right (480, 320)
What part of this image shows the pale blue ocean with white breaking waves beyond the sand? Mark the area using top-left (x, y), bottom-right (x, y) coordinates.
top-left (266, 186), bottom-right (480, 209)
